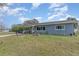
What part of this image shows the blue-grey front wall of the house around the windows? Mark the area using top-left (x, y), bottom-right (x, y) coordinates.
top-left (34, 24), bottom-right (74, 35)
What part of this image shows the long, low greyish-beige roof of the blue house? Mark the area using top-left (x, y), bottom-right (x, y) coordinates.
top-left (35, 20), bottom-right (78, 26)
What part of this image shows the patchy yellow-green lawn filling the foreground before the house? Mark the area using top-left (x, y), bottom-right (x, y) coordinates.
top-left (0, 35), bottom-right (79, 56)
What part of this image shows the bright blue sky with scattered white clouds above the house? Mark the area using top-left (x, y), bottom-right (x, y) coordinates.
top-left (0, 3), bottom-right (79, 27)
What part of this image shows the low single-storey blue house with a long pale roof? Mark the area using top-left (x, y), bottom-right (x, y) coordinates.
top-left (32, 18), bottom-right (78, 35)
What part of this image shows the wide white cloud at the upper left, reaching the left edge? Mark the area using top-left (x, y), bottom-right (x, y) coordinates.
top-left (0, 6), bottom-right (28, 16)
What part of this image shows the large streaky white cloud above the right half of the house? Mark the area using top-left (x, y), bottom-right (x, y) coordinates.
top-left (48, 4), bottom-right (69, 21)
